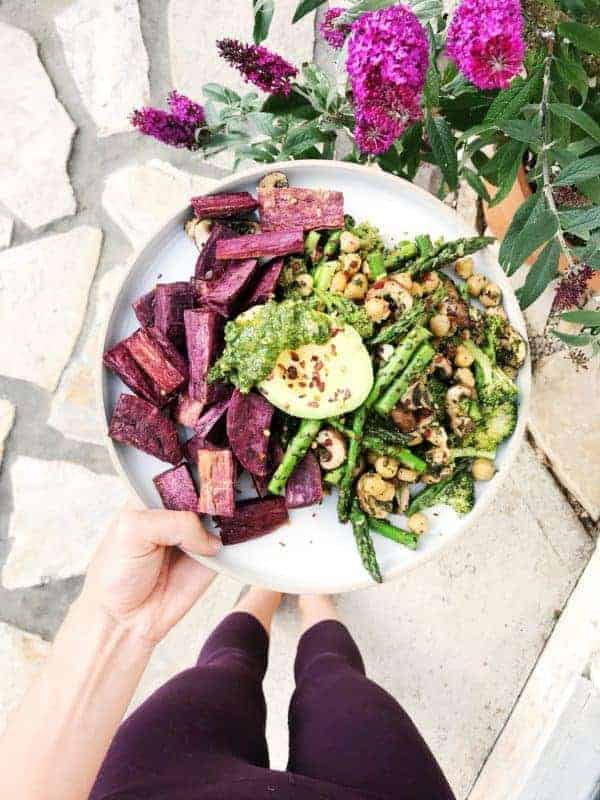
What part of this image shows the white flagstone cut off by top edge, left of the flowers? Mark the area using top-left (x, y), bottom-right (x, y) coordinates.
top-left (56, 0), bottom-right (150, 136)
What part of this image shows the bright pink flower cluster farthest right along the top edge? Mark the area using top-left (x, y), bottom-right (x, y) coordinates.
top-left (447, 0), bottom-right (525, 89)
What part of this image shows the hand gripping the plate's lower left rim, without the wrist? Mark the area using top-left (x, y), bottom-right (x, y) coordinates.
top-left (81, 509), bottom-right (221, 644)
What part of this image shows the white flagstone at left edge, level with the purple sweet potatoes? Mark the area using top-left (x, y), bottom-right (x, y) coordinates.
top-left (0, 225), bottom-right (102, 391)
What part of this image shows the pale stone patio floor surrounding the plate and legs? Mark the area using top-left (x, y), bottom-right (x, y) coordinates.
top-left (0, 0), bottom-right (600, 800)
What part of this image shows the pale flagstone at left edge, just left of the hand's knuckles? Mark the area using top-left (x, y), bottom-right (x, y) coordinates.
top-left (1, 456), bottom-right (128, 589)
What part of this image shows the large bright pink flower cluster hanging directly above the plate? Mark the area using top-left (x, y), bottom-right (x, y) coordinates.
top-left (346, 5), bottom-right (429, 155)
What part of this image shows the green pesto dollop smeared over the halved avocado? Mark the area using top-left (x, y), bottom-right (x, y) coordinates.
top-left (208, 300), bottom-right (331, 392)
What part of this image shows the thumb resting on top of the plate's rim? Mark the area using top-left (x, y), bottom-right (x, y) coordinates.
top-left (119, 510), bottom-right (221, 556)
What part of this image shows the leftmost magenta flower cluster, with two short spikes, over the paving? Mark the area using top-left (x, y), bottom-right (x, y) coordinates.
top-left (131, 91), bottom-right (205, 150)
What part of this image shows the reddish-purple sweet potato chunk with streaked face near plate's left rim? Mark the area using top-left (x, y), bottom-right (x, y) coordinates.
top-left (125, 328), bottom-right (188, 395)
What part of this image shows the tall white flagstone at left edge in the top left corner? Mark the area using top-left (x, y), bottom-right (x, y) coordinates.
top-left (0, 22), bottom-right (75, 228)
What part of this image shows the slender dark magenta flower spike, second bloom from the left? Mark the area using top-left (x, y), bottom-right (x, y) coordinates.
top-left (217, 39), bottom-right (298, 95)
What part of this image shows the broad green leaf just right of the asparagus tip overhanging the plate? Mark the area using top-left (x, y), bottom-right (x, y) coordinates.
top-left (499, 194), bottom-right (558, 275)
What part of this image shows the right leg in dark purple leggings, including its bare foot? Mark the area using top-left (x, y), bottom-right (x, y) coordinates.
top-left (288, 598), bottom-right (454, 800)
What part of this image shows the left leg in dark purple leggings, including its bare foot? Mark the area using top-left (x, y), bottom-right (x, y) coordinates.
top-left (90, 589), bottom-right (280, 800)
